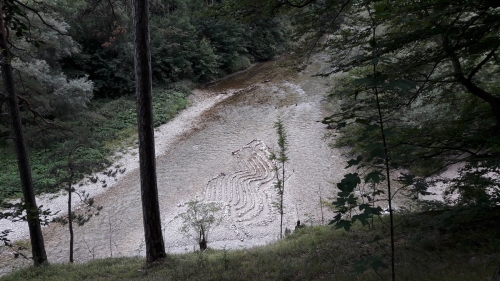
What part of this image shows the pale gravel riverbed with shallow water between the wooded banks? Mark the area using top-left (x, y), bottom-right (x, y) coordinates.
top-left (0, 53), bottom-right (352, 262)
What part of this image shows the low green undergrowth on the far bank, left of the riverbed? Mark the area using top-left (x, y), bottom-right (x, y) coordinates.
top-left (0, 85), bottom-right (191, 201)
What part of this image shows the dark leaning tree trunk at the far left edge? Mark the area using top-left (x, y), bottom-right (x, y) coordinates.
top-left (0, 3), bottom-right (47, 266)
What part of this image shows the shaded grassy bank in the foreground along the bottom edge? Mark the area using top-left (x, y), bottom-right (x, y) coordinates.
top-left (0, 208), bottom-right (500, 280)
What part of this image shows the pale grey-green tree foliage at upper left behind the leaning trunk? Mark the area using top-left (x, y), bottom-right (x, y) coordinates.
top-left (2, 1), bottom-right (93, 120)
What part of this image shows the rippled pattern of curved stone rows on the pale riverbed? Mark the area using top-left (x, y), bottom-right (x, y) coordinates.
top-left (203, 139), bottom-right (276, 237)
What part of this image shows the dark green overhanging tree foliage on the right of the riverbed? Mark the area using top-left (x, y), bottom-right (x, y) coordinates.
top-left (306, 0), bottom-right (500, 205)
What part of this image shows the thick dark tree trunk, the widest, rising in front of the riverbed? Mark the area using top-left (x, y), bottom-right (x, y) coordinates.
top-left (132, 0), bottom-right (166, 263)
